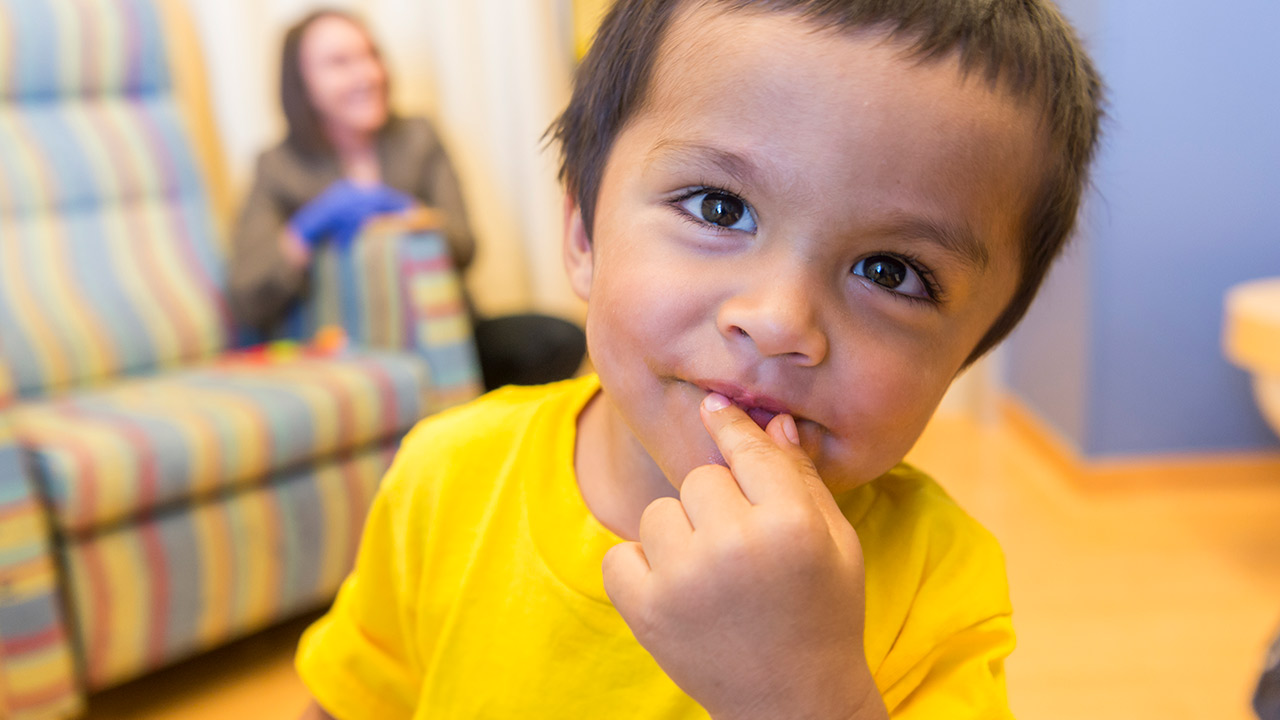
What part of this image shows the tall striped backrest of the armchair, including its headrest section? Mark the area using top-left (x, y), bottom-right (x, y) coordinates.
top-left (0, 0), bottom-right (229, 397)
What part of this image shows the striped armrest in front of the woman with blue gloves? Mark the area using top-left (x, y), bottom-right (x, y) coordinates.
top-left (303, 221), bottom-right (483, 413)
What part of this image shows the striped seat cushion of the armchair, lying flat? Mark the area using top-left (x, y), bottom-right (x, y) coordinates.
top-left (10, 351), bottom-right (430, 532)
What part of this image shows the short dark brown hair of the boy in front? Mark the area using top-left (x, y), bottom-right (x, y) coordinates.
top-left (548, 0), bottom-right (1102, 365)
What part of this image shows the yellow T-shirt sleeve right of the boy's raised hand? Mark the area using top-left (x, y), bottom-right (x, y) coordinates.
top-left (859, 477), bottom-right (1014, 720)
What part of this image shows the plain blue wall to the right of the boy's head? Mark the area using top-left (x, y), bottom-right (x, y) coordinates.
top-left (1007, 0), bottom-right (1280, 456)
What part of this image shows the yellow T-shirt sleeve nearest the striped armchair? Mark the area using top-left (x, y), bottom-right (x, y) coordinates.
top-left (296, 448), bottom-right (421, 720)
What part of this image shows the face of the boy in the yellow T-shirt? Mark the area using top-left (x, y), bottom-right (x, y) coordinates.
top-left (566, 4), bottom-right (1042, 493)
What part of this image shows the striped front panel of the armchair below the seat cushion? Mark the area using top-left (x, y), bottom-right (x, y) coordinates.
top-left (68, 445), bottom-right (394, 689)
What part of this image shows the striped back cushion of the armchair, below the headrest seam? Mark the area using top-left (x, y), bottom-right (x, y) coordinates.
top-left (0, 97), bottom-right (230, 397)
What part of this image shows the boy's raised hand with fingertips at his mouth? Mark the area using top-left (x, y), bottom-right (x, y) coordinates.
top-left (604, 395), bottom-right (887, 720)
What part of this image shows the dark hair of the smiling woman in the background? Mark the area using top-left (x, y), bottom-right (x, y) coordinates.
top-left (280, 8), bottom-right (390, 155)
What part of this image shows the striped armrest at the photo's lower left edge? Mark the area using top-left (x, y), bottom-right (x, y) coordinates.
top-left (0, 411), bottom-right (84, 720)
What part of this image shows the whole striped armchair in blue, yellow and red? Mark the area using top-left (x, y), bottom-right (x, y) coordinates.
top-left (0, 0), bottom-right (479, 720)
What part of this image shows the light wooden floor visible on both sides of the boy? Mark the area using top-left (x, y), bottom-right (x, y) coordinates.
top-left (90, 418), bottom-right (1280, 720)
